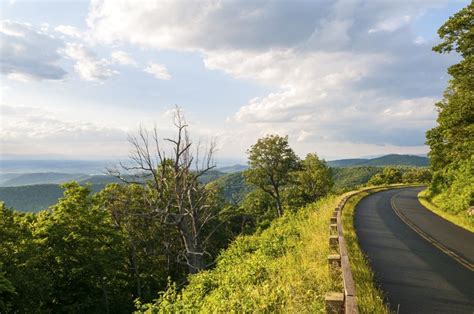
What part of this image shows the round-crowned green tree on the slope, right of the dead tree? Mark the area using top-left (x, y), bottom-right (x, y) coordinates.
top-left (244, 135), bottom-right (299, 216)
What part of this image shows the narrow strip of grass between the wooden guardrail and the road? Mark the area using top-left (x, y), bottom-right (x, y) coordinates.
top-left (342, 188), bottom-right (390, 313)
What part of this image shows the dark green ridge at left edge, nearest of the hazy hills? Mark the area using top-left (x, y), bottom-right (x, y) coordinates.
top-left (0, 184), bottom-right (105, 212)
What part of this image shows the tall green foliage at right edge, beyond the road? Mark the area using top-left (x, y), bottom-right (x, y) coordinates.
top-left (426, 3), bottom-right (474, 220)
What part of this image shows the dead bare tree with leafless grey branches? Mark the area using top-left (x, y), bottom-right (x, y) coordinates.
top-left (109, 108), bottom-right (219, 273)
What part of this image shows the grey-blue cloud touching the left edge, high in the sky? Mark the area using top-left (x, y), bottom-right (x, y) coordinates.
top-left (0, 21), bottom-right (66, 81)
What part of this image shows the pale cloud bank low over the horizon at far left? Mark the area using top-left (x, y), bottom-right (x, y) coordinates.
top-left (0, 104), bottom-right (129, 158)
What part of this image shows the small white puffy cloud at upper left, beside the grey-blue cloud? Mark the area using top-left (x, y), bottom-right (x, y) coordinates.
top-left (62, 43), bottom-right (118, 81)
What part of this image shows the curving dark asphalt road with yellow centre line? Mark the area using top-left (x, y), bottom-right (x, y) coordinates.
top-left (354, 188), bottom-right (474, 314)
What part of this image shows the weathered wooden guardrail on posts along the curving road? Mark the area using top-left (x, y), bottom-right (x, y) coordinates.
top-left (325, 192), bottom-right (359, 314)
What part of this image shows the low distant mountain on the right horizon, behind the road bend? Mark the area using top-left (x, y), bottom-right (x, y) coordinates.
top-left (327, 154), bottom-right (428, 168)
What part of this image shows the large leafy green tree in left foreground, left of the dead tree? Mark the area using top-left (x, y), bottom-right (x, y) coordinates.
top-left (34, 183), bottom-right (132, 313)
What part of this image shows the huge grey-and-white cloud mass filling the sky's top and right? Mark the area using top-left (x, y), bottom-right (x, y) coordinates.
top-left (82, 0), bottom-right (455, 153)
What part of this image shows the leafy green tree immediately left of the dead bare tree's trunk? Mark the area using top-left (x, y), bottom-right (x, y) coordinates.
top-left (96, 184), bottom-right (184, 301)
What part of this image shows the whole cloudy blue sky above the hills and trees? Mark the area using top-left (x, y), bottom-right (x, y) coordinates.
top-left (0, 0), bottom-right (468, 161)
